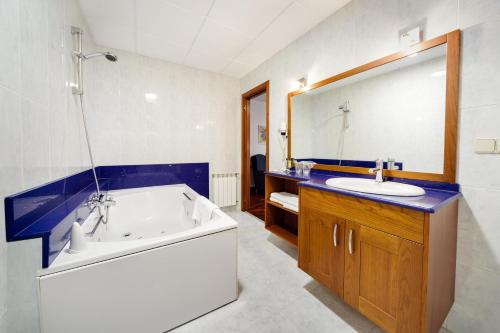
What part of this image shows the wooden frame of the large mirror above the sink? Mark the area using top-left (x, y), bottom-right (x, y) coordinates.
top-left (288, 30), bottom-right (460, 183)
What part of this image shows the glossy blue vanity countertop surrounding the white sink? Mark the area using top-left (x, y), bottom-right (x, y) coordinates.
top-left (267, 170), bottom-right (461, 213)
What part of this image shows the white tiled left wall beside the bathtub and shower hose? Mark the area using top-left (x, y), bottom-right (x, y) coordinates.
top-left (0, 0), bottom-right (95, 332)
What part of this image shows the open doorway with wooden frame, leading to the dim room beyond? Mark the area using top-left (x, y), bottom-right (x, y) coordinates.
top-left (241, 81), bottom-right (269, 220)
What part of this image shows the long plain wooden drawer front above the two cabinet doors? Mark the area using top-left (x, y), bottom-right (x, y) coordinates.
top-left (300, 187), bottom-right (425, 243)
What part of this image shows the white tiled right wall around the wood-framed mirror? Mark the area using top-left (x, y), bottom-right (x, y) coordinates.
top-left (241, 0), bottom-right (500, 333)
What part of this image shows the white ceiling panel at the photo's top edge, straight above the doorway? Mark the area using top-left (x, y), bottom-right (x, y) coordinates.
top-left (209, 0), bottom-right (293, 37)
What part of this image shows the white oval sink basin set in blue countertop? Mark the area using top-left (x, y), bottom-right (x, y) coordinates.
top-left (326, 177), bottom-right (425, 197)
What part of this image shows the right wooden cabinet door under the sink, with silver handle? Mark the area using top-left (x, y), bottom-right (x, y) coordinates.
top-left (344, 221), bottom-right (423, 332)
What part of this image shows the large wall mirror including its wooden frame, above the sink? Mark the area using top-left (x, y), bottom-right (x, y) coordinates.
top-left (288, 31), bottom-right (460, 182)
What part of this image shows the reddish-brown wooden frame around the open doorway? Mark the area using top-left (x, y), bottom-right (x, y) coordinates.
top-left (241, 81), bottom-right (269, 211)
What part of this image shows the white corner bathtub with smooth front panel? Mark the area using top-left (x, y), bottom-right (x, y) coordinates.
top-left (37, 185), bottom-right (238, 333)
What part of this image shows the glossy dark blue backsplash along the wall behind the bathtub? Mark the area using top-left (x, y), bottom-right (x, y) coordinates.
top-left (5, 163), bottom-right (209, 268)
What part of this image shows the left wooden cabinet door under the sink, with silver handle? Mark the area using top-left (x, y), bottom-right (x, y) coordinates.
top-left (299, 207), bottom-right (344, 297)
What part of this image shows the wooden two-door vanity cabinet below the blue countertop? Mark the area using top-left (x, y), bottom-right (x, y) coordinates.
top-left (298, 187), bottom-right (457, 333)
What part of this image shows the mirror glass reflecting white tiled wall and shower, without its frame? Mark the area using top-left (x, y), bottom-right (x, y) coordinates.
top-left (291, 44), bottom-right (446, 173)
